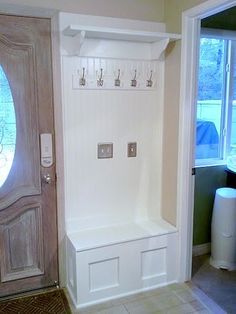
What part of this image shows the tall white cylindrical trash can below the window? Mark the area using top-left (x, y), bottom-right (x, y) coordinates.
top-left (210, 188), bottom-right (236, 270)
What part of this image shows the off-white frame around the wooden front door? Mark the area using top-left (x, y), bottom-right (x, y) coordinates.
top-left (0, 0), bottom-right (66, 286)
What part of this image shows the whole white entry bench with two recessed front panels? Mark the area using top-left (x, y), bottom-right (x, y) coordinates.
top-left (67, 220), bottom-right (177, 308)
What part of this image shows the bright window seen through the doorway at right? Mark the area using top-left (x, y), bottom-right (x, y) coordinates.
top-left (195, 30), bottom-right (236, 165)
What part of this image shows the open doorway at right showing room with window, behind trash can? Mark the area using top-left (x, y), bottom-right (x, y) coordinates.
top-left (192, 7), bottom-right (236, 313)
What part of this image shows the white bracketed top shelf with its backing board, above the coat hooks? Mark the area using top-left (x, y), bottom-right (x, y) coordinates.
top-left (60, 13), bottom-right (181, 60)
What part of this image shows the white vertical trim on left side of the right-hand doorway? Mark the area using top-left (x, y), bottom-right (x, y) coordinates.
top-left (177, 12), bottom-right (200, 281)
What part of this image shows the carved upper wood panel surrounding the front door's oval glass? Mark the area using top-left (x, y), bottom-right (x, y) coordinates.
top-left (0, 36), bottom-right (41, 210)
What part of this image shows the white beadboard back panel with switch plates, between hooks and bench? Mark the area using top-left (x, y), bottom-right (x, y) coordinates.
top-left (63, 57), bottom-right (163, 231)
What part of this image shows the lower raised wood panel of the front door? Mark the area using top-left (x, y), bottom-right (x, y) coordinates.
top-left (0, 204), bottom-right (44, 282)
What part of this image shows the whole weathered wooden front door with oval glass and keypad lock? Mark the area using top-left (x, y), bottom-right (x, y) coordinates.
top-left (0, 15), bottom-right (58, 296)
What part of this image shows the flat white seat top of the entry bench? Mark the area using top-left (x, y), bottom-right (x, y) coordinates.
top-left (67, 220), bottom-right (177, 252)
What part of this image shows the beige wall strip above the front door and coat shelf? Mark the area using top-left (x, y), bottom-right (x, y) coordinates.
top-left (0, 0), bottom-right (164, 22)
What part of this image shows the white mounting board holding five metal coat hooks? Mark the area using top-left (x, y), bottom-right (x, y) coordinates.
top-left (72, 57), bottom-right (160, 91)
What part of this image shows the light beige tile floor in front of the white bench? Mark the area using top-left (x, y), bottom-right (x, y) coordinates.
top-left (65, 284), bottom-right (224, 314)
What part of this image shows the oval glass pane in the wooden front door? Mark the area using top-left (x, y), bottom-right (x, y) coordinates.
top-left (0, 65), bottom-right (16, 187)
